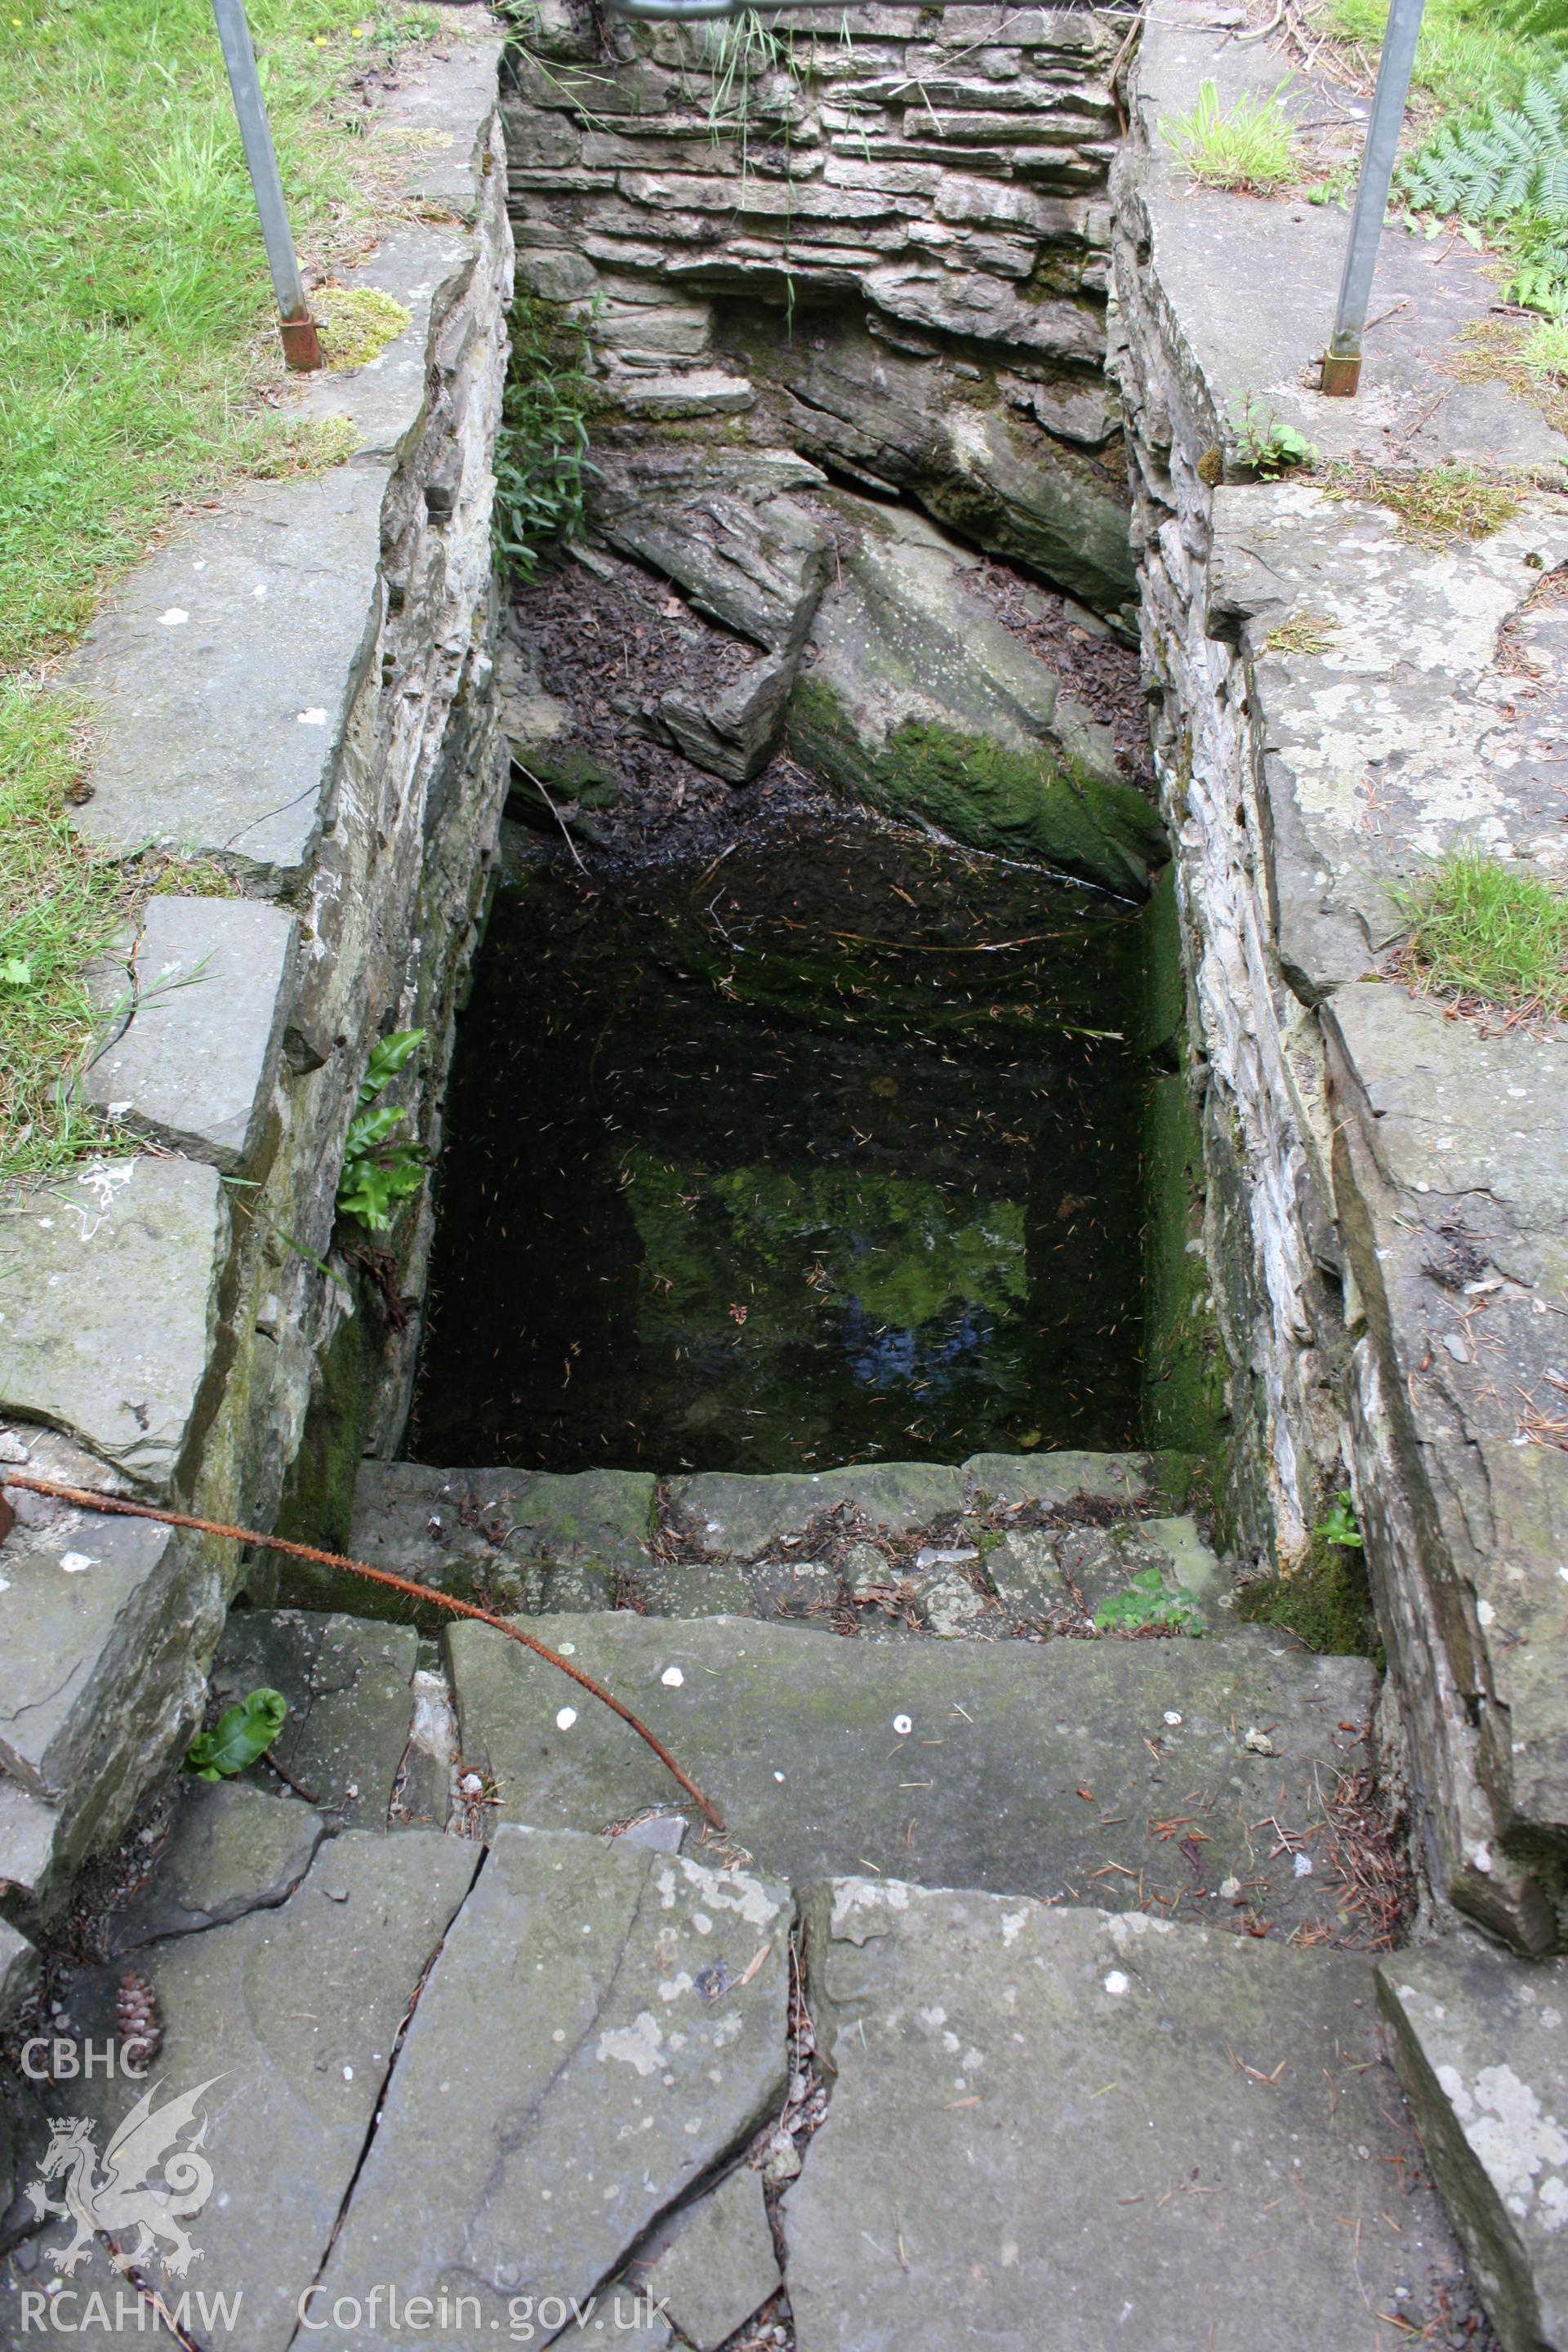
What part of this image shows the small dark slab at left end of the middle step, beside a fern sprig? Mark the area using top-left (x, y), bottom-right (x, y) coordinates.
top-left (212, 1609), bottom-right (418, 1828)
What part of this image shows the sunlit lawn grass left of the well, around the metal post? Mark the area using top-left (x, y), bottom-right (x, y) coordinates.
top-left (0, 0), bottom-right (439, 1176)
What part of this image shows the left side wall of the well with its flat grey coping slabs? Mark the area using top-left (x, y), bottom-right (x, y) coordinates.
top-left (0, 27), bottom-right (513, 1919)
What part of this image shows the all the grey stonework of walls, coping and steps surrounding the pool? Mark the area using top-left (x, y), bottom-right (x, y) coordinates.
top-left (0, 0), bottom-right (1568, 2352)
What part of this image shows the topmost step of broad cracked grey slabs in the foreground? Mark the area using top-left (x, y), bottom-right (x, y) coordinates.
top-left (0, 1799), bottom-right (1467, 2352)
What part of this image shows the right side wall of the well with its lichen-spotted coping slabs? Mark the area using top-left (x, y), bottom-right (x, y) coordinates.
top-left (1112, 5), bottom-right (1568, 1952)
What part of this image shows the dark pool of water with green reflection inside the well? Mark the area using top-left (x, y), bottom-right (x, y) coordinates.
top-left (409, 821), bottom-right (1145, 1470)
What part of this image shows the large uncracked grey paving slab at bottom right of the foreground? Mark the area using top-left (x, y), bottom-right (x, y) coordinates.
top-left (783, 1877), bottom-right (1460, 2352)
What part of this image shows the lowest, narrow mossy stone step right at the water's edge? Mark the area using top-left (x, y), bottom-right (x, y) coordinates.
top-left (350, 1454), bottom-right (1227, 1639)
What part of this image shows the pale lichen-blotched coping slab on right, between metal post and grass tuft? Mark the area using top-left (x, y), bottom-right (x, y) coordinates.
top-left (1209, 487), bottom-right (1568, 1000)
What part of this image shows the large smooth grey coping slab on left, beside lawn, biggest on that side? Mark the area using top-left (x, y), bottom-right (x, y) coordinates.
top-left (70, 457), bottom-right (388, 884)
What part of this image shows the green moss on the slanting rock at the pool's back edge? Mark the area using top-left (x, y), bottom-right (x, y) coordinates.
top-left (787, 677), bottom-right (1164, 893)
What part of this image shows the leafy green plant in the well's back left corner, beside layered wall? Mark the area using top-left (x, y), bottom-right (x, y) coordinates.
top-left (493, 292), bottom-right (595, 583)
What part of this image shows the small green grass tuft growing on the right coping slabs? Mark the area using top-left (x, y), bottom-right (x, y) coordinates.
top-left (1399, 849), bottom-right (1568, 1021)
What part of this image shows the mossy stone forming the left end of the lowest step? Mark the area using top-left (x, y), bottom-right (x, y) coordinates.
top-left (348, 1460), bottom-right (656, 1611)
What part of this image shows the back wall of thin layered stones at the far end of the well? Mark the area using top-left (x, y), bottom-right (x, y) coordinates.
top-left (506, 0), bottom-right (1135, 633)
